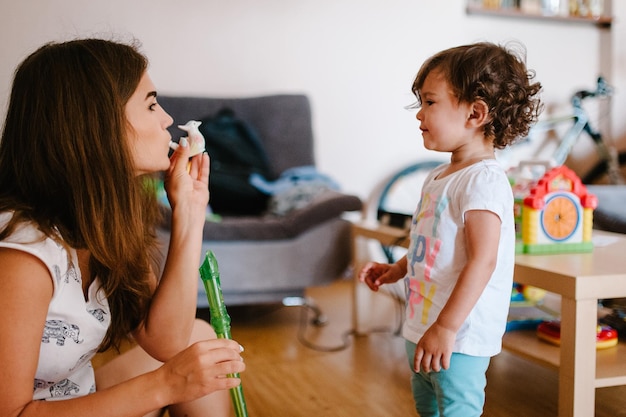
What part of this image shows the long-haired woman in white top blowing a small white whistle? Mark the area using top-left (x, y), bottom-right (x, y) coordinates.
top-left (0, 39), bottom-right (245, 416)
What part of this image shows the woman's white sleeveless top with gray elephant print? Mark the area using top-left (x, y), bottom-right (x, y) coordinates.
top-left (0, 213), bottom-right (111, 400)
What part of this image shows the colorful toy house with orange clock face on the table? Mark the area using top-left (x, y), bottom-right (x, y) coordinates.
top-left (511, 166), bottom-right (598, 254)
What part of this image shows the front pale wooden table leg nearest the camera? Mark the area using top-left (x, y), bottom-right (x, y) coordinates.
top-left (559, 297), bottom-right (597, 417)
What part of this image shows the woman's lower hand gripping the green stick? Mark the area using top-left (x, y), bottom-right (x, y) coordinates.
top-left (155, 339), bottom-right (246, 404)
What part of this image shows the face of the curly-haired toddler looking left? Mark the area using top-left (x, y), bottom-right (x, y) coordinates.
top-left (415, 70), bottom-right (471, 152)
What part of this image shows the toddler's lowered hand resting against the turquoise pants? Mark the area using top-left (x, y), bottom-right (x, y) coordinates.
top-left (413, 322), bottom-right (456, 372)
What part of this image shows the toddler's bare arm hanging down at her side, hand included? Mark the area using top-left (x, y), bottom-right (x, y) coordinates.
top-left (413, 210), bottom-right (501, 372)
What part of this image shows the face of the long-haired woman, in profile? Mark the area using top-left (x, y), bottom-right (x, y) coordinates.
top-left (126, 72), bottom-right (174, 175)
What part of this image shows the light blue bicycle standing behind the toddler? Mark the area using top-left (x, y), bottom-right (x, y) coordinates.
top-left (366, 77), bottom-right (626, 263)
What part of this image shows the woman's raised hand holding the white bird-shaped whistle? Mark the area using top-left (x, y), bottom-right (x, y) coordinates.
top-left (165, 138), bottom-right (210, 218)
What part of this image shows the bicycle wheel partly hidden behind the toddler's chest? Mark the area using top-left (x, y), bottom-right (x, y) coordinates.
top-left (376, 161), bottom-right (443, 263)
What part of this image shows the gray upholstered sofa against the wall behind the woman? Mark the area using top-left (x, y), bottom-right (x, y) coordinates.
top-left (158, 94), bottom-right (362, 307)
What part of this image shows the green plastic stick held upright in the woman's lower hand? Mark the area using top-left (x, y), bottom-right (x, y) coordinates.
top-left (200, 251), bottom-right (248, 417)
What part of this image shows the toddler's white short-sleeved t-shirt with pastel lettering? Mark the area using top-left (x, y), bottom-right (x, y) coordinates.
top-left (402, 160), bottom-right (515, 357)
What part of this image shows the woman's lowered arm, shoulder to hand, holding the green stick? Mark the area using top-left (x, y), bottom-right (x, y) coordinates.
top-left (0, 249), bottom-right (245, 417)
